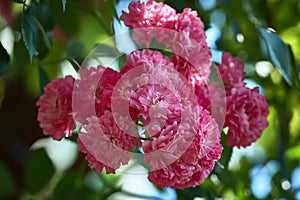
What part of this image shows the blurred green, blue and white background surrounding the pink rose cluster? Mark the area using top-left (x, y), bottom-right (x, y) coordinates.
top-left (0, 0), bottom-right (300, 200)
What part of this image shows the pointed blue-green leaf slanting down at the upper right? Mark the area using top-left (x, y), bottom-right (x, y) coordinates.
top-left (257, 27), bottom-right (293, 85)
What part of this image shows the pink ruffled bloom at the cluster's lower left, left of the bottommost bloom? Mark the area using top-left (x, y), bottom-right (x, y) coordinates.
top-left (78, 111), bottom-right (141, 174)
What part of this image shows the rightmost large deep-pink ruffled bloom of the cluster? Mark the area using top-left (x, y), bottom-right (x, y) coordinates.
top-left (225, 86), bottom-right (269, 147)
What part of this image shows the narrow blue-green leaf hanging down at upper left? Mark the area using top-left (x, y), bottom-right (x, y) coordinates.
top-left (21, 11), bottom-right (39, 62)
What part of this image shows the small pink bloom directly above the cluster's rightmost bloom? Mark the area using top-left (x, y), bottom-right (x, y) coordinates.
top-left (218, 52), bottom-right (245, 91)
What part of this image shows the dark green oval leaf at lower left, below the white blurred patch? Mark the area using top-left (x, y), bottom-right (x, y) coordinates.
top-left (26, 150), bottom-right (54, 194)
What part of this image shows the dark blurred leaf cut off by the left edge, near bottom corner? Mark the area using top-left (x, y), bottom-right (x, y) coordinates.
top-left (0, 162), bottom-right (16, 198)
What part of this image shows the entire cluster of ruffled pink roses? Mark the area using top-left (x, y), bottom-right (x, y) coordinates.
top-left (37, 0), bottom-right (268, 189)
